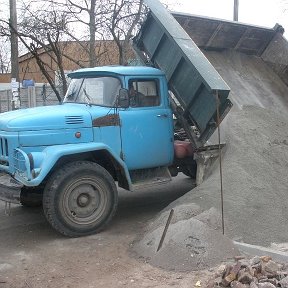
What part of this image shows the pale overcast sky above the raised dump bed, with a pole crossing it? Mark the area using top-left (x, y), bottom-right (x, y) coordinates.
top-left (162, 0), bottom-right (288, 39)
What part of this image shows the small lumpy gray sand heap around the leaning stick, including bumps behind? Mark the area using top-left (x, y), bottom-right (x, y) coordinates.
top-left (133, 203), bottom-right (239, 271)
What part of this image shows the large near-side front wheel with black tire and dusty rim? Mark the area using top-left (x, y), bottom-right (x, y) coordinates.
top-left (43, 161), bottom-right (118, 237)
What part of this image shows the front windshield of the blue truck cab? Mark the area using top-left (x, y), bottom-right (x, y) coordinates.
top-left (63, 77), bottom-right (121, 107)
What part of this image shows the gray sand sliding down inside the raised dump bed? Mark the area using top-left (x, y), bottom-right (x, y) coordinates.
top-left (203, 50), bottom-right (288, 116)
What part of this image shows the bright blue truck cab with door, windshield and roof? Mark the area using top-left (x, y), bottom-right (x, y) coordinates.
top-left (64, 66), bottom-right (173, 171)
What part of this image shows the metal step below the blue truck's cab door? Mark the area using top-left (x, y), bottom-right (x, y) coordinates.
top-left (130, 167), bottom-right (172, 190)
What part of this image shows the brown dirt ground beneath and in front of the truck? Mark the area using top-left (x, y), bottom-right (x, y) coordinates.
top-left (0, 175), bottom-right (218, 288)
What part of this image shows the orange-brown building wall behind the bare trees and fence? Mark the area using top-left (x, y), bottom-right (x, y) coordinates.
top-left (0, 40), bottom-right (135, 83)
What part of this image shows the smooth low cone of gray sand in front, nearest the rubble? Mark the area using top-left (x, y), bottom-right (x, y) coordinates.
top-left (133, 218), bottom-right (238, 272)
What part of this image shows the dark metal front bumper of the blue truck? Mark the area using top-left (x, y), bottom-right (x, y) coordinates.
top-left (0, 173), bottom-right (24, 204)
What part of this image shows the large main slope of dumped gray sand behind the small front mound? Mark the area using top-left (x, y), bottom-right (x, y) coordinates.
top-left (171, 106), bottom-right (288, 246)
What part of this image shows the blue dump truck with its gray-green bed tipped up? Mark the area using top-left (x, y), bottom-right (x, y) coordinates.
top-left (0, 0), bottom-right (232, 237)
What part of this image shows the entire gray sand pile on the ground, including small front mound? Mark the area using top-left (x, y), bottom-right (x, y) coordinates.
top-left (134, 106), bottom-right (288, 271)
